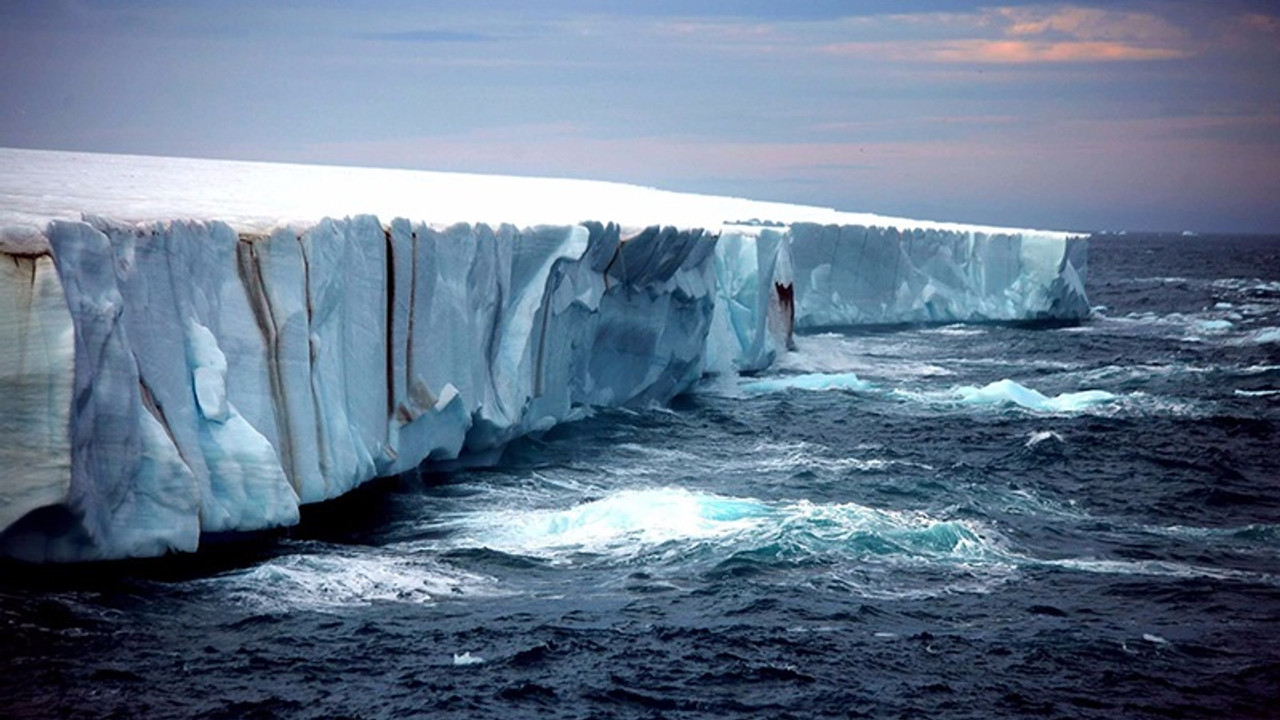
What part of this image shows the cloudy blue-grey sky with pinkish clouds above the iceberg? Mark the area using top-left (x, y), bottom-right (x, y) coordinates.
top-left (0, 0), bottom-right (1280, 233)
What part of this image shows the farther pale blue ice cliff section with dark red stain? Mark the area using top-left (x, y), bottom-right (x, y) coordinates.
top-left (708, 223), bottom-right (1089, 373)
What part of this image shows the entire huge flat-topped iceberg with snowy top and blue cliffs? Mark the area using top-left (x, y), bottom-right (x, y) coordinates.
top-left (0, 149), bottom-right (1088, 561)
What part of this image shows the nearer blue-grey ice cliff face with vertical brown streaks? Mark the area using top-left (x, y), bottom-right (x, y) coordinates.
top-left (0, 215), bottom-right (716, 561)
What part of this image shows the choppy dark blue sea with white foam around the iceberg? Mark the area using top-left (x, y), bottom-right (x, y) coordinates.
top-left (0, 236), bottom-right (1280, 717)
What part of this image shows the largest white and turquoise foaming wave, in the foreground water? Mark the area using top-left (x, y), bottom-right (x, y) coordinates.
top-left (448, 488), bottom-right (1004, 566)
